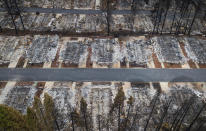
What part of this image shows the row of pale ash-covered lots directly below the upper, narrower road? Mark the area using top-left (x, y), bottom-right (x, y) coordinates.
top-left (0, 12), bottom-right (206, 35)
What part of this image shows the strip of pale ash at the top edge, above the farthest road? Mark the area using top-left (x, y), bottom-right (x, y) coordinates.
top-left (0, 0), bottom-right (157, 10)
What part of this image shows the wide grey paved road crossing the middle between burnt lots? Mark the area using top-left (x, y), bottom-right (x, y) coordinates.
top-left (0, 68), bottom-right (206, 82)
